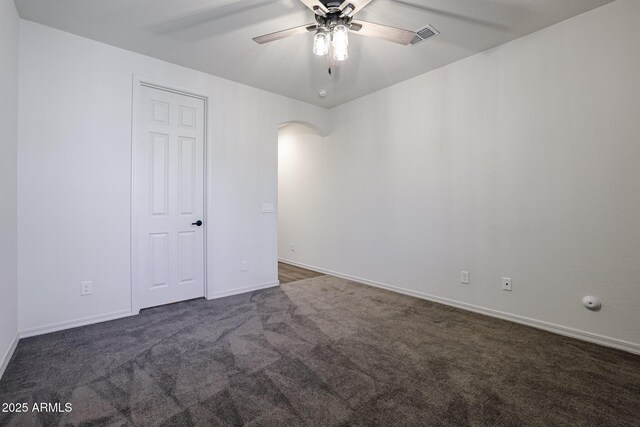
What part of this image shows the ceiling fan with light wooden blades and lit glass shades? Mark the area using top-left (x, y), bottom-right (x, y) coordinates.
top-left (253, 0), bottom-right (416, 65)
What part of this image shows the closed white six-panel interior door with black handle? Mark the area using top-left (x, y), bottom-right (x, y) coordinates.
top-left (134, 86), bottom-right (205, 308)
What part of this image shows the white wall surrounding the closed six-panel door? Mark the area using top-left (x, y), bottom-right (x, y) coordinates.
top-left (18, 21), bottom-right (328, 335)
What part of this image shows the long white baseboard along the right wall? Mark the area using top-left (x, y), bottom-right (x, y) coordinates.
top-left (278, 258), bottom-right (640, 354)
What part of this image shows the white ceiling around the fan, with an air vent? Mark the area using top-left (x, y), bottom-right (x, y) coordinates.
top-left (15, 0), bottom-right (613, 107)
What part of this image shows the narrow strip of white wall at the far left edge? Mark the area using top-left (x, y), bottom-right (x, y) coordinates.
top-left (0, 0), bottom-right (19, 376)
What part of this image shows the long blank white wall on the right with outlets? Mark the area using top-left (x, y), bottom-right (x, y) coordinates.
top-left (279, 0), bottom-right (640, 351)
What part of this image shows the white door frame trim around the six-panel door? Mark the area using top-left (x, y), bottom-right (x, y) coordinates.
top-left (130, 74), bottom-right (209, 314)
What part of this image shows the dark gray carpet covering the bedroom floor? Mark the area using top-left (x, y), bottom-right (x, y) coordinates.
top-left (0, 276), bottom-right (640, 426)
